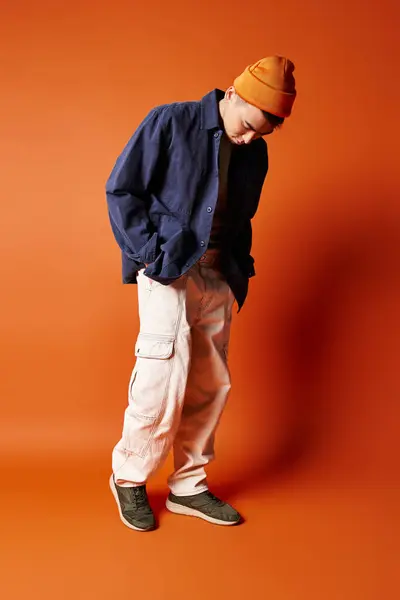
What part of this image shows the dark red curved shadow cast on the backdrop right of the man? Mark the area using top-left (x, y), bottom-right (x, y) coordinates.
top-left (219, 188), bottom-right (400, 498)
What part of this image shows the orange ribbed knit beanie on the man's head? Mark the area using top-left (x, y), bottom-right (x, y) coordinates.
top-left (233, 56), bottom-right (296, 117)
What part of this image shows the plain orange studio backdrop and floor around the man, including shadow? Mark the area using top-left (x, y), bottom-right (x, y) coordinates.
top-left (0, 0), bottom-right (400, 600)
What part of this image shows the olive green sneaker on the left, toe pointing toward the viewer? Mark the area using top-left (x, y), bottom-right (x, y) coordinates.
top-left (110, 475), bottom-right (156, 531)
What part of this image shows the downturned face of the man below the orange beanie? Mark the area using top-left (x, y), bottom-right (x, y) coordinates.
top-left (220, 87), bottom-right (274, 145)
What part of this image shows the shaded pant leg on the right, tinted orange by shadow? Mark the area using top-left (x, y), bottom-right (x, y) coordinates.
top-left (168, 267), bottom-right (234, 496)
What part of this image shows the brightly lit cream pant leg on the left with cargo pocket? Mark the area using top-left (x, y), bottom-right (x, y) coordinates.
top-left (112, 271), bottom-right (195, 486)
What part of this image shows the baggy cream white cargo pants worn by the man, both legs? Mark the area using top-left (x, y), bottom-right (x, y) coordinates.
top-left (112, 251), bottom-right (234, 496)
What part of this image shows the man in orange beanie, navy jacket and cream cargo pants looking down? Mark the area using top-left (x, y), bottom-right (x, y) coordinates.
top-left (106, 56), bottom-right (296, 531)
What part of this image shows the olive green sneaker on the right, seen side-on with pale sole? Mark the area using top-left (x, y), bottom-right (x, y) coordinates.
top-left (166, 490), bottom-right (241, 525)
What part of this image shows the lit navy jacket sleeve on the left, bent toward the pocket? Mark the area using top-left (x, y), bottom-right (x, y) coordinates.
top-left (106, 109), bottom-right (163, 263)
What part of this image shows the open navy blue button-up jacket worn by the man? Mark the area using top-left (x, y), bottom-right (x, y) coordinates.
top-left (106, 89), bottom-right (268, 310)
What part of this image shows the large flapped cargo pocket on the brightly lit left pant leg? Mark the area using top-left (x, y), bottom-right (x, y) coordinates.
top-left (122, 333), bottom-right (174, 458)
